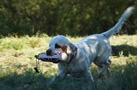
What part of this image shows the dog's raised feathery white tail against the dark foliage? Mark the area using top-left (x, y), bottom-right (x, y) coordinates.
top-left (102, 6), bottom-right (135, 38)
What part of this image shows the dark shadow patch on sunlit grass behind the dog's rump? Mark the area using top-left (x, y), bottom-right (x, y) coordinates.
top-left (112, 45), bottom-right (137, 56)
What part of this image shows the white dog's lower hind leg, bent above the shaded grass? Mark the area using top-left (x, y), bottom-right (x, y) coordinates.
top-left (97, 59), bottom-right (111, 78)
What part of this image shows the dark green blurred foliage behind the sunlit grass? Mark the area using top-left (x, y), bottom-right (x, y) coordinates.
top-left (0, 0), bottom-right (137, 36)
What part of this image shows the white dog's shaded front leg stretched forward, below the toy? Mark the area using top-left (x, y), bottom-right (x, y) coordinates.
top-left (51, 70), bottom-right (67, 83)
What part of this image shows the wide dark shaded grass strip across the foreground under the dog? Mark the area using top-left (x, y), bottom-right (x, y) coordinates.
top-left (0, 61), bottom-right (137, 90)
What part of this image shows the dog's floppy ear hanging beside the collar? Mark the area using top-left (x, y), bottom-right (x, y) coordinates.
top-left (66, 43), bottom-right (77, 56)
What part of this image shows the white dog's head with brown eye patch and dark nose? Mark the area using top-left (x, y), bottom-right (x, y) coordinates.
top-left (46, 35), bottom-right (77, 60)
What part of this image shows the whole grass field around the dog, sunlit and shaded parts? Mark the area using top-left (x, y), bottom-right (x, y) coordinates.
top-left (0, 35), bottom-right (137, 90)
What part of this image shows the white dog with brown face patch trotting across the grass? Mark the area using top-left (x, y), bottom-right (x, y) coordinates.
top-left (46, 7), bottom-right (134, 81)
